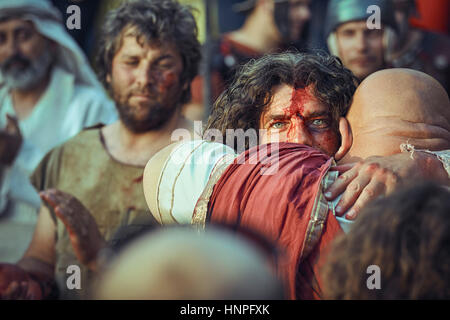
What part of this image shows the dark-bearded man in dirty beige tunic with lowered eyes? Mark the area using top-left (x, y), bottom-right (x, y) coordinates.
top-left (0, 0), bottom-right (200, 299)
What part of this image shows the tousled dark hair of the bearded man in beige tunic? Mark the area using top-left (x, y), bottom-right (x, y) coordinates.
top-left (97, 0), bottom-right (201, 103)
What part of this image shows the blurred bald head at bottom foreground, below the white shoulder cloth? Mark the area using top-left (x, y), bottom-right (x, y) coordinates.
top-left (94, 227), bottom-right (283, 300)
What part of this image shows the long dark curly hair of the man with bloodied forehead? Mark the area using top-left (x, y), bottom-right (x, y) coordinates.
top-left (206, 52), bottom-right (358, 149)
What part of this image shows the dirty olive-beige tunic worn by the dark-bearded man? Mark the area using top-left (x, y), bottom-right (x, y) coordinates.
top-left (31, 127), bottom-right (157, 299)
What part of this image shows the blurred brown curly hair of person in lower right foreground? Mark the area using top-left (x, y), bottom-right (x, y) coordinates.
top-left (321, 183), bottom-right (450, 299)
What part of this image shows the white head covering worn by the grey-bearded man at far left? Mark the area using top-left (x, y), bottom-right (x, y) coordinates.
top-left (0, 0), bottom-right (102, 88)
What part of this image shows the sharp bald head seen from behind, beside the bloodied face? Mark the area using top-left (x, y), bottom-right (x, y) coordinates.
top-left (342, 69), bottom-right (450, 163)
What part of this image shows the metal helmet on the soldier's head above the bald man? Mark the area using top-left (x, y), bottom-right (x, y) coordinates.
top-left (325, 0), bottom-right (397, 37)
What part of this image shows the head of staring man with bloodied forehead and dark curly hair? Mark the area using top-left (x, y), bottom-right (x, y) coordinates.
top-left (207, 53), bottom-right (352, 158)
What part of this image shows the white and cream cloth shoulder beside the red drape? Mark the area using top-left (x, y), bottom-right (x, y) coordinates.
top-left (143, 140), bottom-right (236, 224)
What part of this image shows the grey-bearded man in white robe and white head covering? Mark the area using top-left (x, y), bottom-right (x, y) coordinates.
top-left (0, 0), bottom-right (117, 262)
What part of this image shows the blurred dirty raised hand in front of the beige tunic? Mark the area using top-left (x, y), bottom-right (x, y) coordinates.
top-left (40, 189), bottom-right (106, 270)
